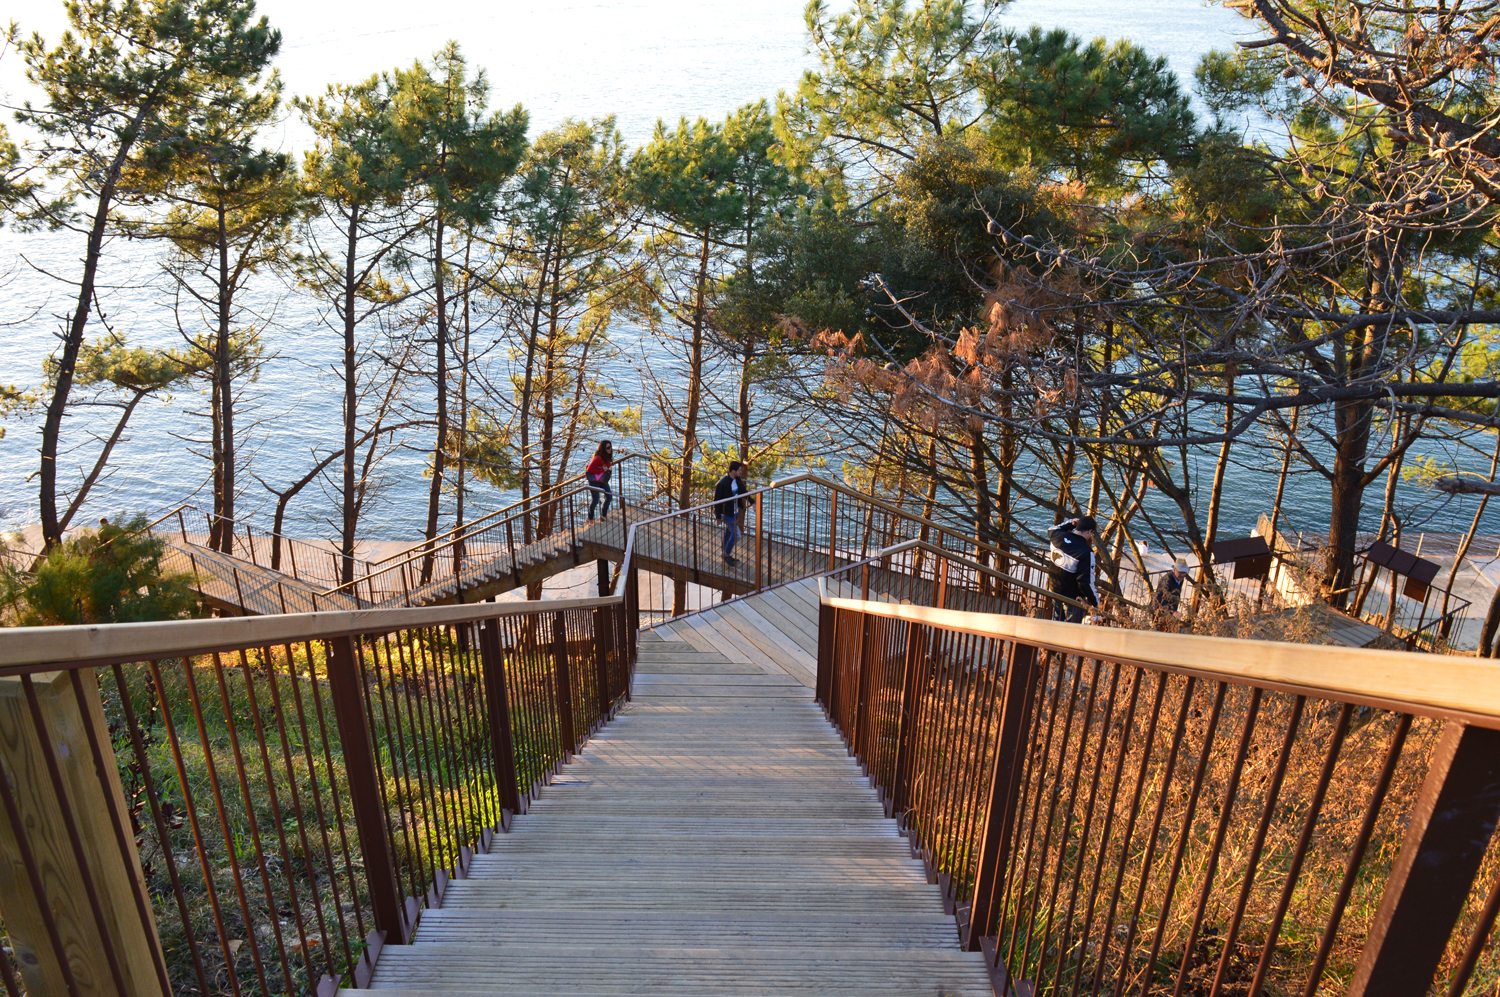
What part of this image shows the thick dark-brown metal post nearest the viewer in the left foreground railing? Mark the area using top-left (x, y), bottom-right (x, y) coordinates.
top-left (329, 637), bottom-right (414, 945)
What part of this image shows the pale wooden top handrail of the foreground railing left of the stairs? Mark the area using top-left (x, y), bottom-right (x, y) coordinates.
top-left (0, 595), bottom-right (621, 675)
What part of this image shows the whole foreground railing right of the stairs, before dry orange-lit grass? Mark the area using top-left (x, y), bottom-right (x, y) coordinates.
top-left (818, 597), bottom-right (1500, 997)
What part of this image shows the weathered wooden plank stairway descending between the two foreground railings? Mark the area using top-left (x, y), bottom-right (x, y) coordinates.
top-left (357, 623), bottom-right (993, 997)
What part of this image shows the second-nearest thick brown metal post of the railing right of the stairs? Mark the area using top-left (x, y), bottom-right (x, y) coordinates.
top-left (960, 643), bottom-right (1037, 952)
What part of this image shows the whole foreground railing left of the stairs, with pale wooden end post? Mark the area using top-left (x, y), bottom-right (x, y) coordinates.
top-left (0, 598), bottom-right (633, 997)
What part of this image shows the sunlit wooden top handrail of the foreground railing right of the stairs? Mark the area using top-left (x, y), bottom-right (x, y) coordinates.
top-left (824, 598), bottom-right (1500, 727)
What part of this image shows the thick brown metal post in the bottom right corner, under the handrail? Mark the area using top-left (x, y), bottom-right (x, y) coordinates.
top-left (1349, 721), bottom-right (1500, 997)
